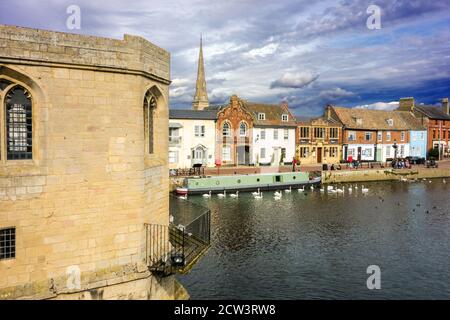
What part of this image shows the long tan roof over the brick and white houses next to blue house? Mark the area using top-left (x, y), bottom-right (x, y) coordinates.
top-left (333, 107), bottom-right (426, 130)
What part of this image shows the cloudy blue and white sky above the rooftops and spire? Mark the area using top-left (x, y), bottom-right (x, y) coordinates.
top-left (0, 0), bottom-right (450, 117)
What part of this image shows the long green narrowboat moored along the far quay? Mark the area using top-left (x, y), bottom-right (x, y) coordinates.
top-left (176, 172), bottom-right (321, 195)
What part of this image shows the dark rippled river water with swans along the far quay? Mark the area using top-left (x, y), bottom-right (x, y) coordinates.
top-left (171, 179), bottom-right (450, 299)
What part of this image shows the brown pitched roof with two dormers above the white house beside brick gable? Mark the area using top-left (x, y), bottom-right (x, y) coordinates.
top-left (242, 100), bottom-right (297, 127)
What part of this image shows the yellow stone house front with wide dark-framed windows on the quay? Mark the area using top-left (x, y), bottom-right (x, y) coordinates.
top-left (297, 118), bottom-right (342, 165)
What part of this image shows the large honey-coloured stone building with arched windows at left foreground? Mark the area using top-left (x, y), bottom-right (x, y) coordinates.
top-left (0, 25), bottom-right (184, 299)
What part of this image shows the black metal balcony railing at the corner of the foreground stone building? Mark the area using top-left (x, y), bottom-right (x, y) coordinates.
top-left (146, 206), bottom-right (211, 276)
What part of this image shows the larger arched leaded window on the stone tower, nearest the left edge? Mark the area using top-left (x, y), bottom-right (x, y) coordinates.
top-left (5, 86), bottom-right (33, 160)
